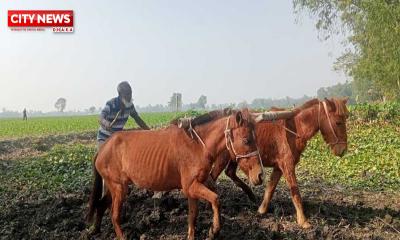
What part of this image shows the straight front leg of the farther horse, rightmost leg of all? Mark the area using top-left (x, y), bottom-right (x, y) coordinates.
top-left (282, 164), bottom-right (311, 228)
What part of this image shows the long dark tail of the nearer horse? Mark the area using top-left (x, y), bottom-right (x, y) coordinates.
top-left (86, 153), bottom-right (103, 222)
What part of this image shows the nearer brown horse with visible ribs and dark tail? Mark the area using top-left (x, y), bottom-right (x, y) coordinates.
top-left (88, 110), bottom-right (263, 239)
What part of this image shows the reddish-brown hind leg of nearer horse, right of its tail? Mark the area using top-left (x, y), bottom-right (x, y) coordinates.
top-left (109, 183), bottom-right (127, 240)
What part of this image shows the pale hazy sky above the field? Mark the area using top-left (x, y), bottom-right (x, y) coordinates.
top-left (0, 0), bottom-right (346, 111)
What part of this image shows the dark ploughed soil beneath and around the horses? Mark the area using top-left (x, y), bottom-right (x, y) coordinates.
top-left (0, 135), bottom-right (400, 239)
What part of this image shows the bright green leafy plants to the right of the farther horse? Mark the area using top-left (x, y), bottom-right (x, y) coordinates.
top-left (298, 122), bottom-right (400, 191)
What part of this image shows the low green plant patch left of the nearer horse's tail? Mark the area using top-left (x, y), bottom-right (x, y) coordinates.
top-left (0, 144), bottom-right (95, 199)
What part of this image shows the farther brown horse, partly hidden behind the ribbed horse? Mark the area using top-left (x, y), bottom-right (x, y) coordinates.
top-left (211, 98), bottom-right (348, 228)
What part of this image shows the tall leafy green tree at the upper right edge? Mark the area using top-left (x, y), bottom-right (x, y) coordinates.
top-left (293, 0), bottom-right (400, 101)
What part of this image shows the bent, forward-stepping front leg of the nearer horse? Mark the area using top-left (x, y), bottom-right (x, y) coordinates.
top-left (188, 180), bottom-right (221, 239)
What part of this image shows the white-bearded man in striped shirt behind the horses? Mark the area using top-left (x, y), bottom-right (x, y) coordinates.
top-left (97, 82), bottom-right (150, 150)
